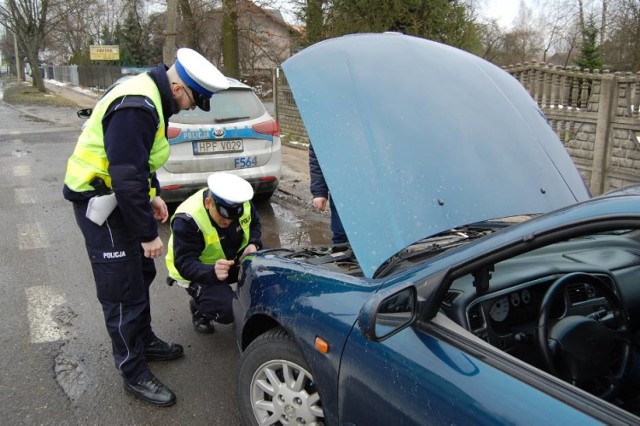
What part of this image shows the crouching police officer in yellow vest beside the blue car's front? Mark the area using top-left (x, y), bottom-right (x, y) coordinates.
top-left (166, 172), bottom-right (262, 333)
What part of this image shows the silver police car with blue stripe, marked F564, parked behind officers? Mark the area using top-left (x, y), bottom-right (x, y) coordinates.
top-left (157, 78), bottom-right (281, 202)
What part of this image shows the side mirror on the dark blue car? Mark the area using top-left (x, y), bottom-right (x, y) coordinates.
top-left (360, 287), bottom-right (417, 340)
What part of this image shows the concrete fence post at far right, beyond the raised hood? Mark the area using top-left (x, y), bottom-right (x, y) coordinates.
top-left (589, 74), bottom-right (616, 196)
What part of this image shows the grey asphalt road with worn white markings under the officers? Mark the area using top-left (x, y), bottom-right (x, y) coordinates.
top-left (0, 79), bottom-right (330, 425)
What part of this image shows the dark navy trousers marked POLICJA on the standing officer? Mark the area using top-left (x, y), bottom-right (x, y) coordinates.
top-left (73, 202), bottom-right (156, 383)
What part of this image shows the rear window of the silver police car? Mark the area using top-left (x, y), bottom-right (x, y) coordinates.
top-left (171, 89), bottom-right (265, 124)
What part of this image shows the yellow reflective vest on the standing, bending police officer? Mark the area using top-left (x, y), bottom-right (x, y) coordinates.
top-left (64, 73), bottom-right (170, 199)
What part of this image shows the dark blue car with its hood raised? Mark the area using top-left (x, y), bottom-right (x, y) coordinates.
top-left (234, 33), bottom-right (640, 425)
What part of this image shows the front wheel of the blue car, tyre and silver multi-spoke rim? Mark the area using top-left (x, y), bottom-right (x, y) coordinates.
top-left (238, 328), bottom-right (324, 425)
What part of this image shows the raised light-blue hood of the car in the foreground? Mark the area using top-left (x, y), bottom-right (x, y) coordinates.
top-left (283, 33), bottom-right (590, 277)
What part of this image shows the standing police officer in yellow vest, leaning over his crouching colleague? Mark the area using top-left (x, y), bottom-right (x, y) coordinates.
top-left (63, 48), bottom-right (228, 406)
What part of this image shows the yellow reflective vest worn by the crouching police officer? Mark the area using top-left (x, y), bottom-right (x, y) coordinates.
top-left (165, 188), bottom-right (251, 283)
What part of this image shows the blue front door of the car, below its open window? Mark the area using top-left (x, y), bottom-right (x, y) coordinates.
top-left (338, 308), bottom-right (615, 425)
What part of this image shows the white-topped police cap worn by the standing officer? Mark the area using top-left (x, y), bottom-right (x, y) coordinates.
top-left (175, 47), bottom-right (229, 111)
